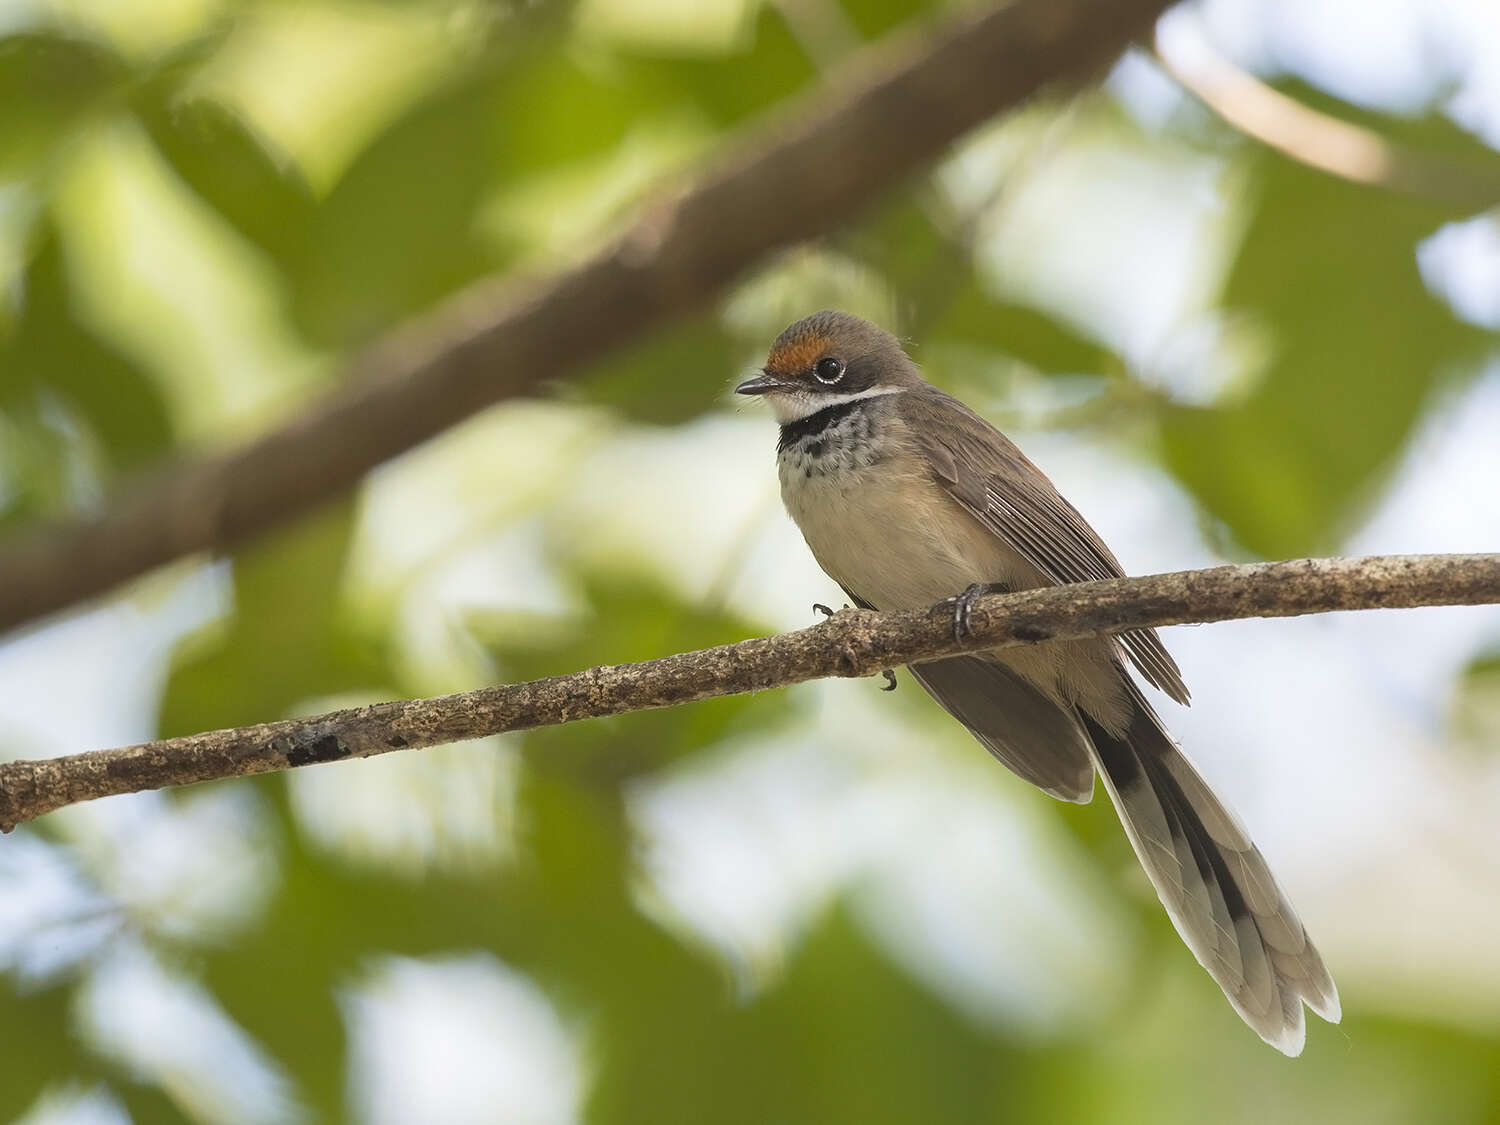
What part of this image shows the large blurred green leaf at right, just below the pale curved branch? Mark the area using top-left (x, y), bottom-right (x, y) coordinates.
top-left (1161, 134), bottom-right (1484, 557)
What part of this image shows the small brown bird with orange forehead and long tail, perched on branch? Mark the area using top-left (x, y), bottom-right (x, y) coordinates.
top-left (735, 311), bottom-right (1341, 1056)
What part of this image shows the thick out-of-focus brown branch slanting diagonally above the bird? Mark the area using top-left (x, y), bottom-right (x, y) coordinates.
top-left (0, 0), bottom-right (1167, 630)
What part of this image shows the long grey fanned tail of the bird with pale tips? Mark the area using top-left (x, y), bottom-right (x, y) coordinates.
top-left (1080, 686), bottom-right (1341, 1055)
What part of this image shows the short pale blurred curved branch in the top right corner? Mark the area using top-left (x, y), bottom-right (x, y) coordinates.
top-left (1155, 18), bottom-right (1500, 210)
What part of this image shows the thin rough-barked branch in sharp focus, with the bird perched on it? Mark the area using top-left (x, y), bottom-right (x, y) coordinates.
top-left (0, 555), bottom-right (1500, 831)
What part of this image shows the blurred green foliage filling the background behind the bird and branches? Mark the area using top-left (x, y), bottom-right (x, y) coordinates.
top-left (0, 0), bottom-right (1500, 1125)
